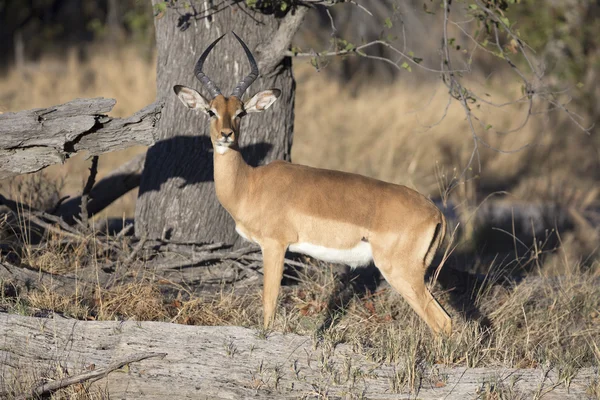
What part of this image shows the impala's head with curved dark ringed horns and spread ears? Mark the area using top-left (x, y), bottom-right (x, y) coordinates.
top-left (173, 32), bottom-right (281, 154)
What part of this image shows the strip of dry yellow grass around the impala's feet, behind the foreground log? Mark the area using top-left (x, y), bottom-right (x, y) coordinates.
top-left (0, 247), bottom-right (600, 376)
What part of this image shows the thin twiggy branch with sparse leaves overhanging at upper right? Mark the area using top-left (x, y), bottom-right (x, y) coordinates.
top-left (286, 0), bottom-right (593, 199)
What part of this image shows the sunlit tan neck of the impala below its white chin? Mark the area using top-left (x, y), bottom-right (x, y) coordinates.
top-left (213, 148), bottom-right (252, 219)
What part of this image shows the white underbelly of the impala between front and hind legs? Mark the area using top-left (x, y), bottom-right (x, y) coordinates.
top-left (288, 242), bottom-right (373, 268)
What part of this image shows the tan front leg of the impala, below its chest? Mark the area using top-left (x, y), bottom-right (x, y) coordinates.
top-left (261, 241), bottom-right (286, 328)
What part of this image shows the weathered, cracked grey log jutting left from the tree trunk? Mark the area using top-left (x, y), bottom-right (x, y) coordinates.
top-left (0, 97), bottom-right (163, 179)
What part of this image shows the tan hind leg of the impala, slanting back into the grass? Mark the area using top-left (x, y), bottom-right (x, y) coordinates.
top-left (376, 261), bottom-right (452, 335)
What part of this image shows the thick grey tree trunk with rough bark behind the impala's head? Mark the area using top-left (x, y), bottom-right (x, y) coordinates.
top-left (135, 0), bottom-right (298, 246)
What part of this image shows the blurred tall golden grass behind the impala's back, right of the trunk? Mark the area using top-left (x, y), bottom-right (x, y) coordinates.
top-left (292, 68), bottom-right (600, 205)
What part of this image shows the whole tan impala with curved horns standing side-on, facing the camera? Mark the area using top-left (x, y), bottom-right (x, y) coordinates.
top-left (173, 33), bottom-right (451, 334)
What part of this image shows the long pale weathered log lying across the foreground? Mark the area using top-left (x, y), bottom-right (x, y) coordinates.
top-left (0, 314), bottom-right (595, 400)
